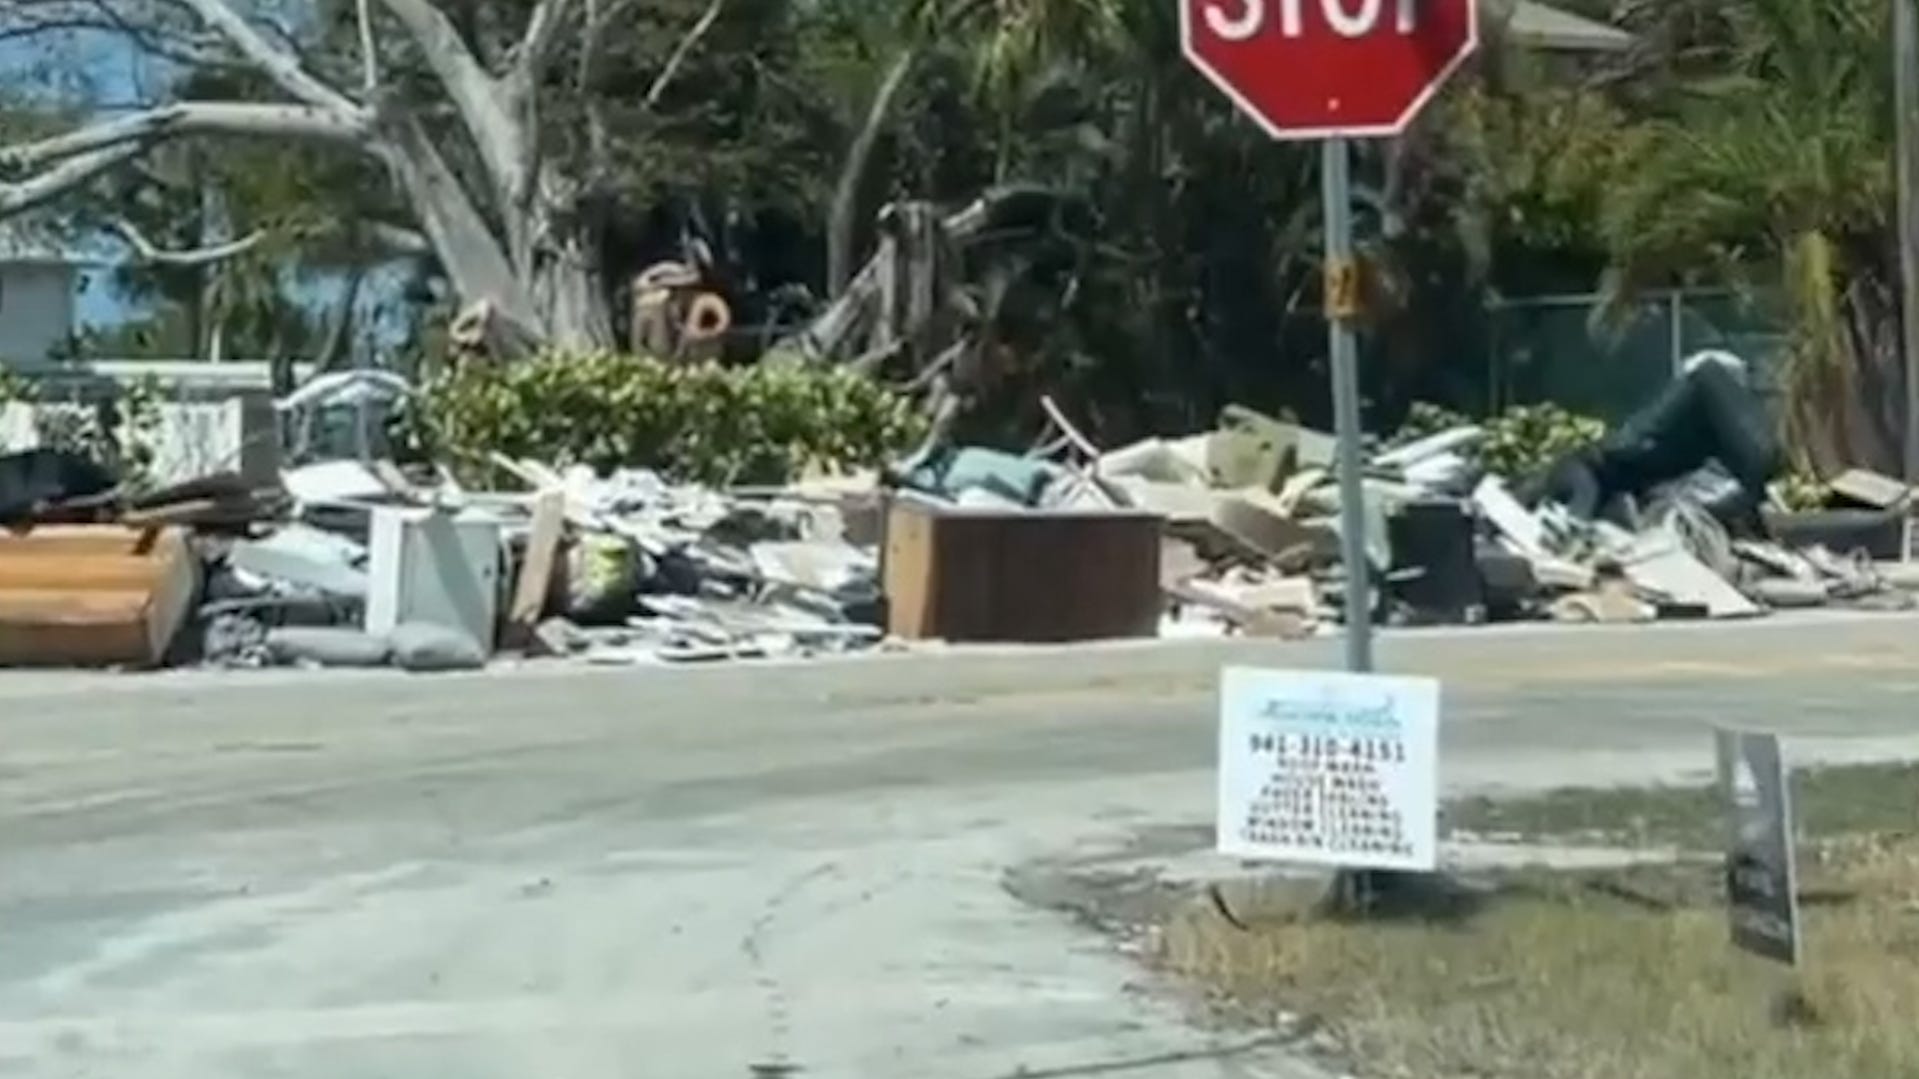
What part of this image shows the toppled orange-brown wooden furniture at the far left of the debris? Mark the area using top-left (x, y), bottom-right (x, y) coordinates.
top-left (0, 524), bottom-right (200, 668)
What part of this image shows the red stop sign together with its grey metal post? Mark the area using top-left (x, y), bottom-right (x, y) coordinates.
top-left (1178, 0), bottom-right (1480, 672)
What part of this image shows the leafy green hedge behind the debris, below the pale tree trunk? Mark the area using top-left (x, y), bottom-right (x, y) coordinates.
top-left (420, 351), bottom-right (923, 484)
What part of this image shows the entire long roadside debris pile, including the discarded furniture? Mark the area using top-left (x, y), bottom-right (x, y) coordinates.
top-left (0, 353), bottom-right (1919, 670)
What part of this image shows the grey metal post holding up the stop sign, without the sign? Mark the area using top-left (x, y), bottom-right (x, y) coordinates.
top-left (1320, 136), bottom-right (1372, 672)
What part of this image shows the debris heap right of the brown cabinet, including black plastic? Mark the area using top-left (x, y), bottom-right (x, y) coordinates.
top-left (1084, 351), bottom-right (1913, 635)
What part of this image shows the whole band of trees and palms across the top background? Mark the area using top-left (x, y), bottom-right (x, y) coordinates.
top-left (0, 0), bottom-right (1902, 461)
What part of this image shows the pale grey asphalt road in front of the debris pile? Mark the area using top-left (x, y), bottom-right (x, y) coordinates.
top-left (0, 616), bottom-right (1919, 1079)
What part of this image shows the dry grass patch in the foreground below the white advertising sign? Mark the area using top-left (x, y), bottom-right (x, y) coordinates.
top-left (1161, 837), bottom-right (1919, 1079)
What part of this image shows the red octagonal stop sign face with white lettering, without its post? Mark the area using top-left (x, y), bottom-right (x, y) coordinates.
top-left (1178, 0), bottom-right (1480, 138)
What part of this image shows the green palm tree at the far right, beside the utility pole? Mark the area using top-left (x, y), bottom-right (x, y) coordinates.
top-left (1602, 0), bottom-right (1904, 470)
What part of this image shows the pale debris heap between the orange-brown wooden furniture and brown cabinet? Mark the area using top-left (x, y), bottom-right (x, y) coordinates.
top-left (201, 451), bottom-right (885, 670)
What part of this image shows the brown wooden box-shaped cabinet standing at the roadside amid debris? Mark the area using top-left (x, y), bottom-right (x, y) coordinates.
top-left (881, 497), bottom-right (1163, 643)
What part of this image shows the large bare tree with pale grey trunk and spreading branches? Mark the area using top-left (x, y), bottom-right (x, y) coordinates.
top-left (0, 0), bottom-right (748, 346)
